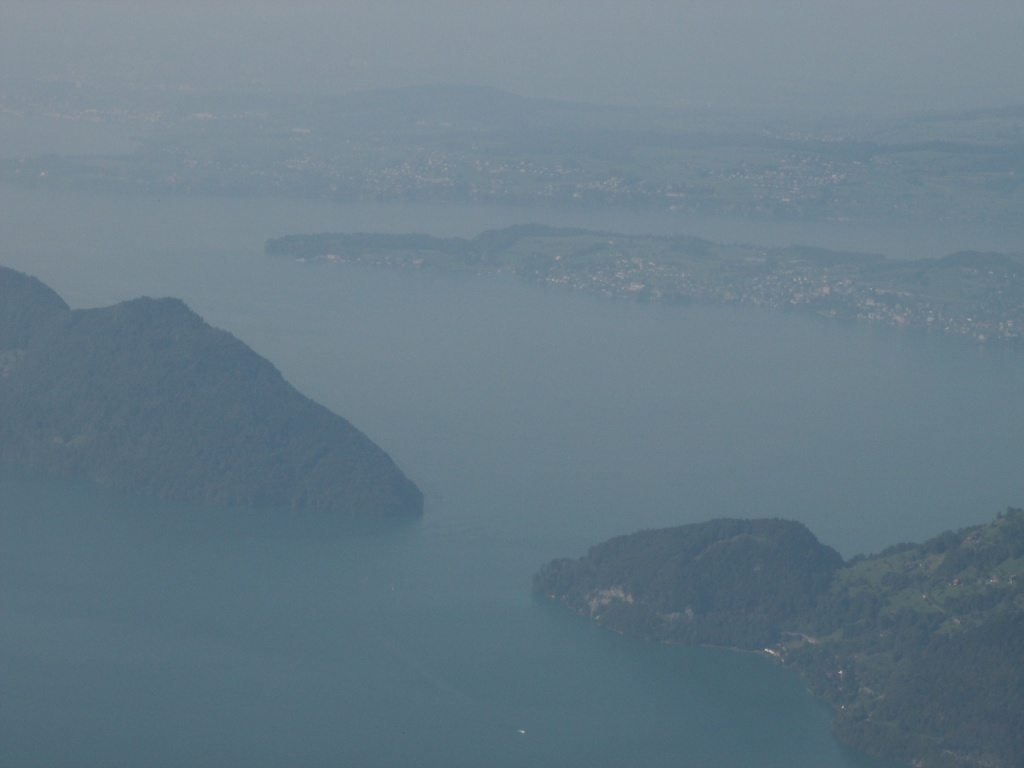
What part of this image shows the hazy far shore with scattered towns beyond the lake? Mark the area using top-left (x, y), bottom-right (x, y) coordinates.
top-left (0, 86), bottom-right (1024, 225)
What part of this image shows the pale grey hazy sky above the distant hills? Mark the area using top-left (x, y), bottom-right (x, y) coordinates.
top-left (6, 0), bottom-right (1024, 112)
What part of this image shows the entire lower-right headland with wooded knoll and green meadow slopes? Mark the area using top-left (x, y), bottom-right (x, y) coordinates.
top-left (532, 509), bottom-right (1024, 768)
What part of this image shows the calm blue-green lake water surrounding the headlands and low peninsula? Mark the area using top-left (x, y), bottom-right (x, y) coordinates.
top-left (0, 189), bottom-right (1024, 768)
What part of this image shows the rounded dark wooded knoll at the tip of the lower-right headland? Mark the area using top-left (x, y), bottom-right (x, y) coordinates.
top-left (534, 519), bottom-right (843, 649)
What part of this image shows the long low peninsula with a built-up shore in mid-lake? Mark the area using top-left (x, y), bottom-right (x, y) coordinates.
top-left (266, 224), bottom-right (1024, 348)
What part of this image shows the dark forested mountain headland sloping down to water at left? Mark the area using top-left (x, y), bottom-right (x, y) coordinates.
top-left (0, 267), bottom-right (423, 518)
